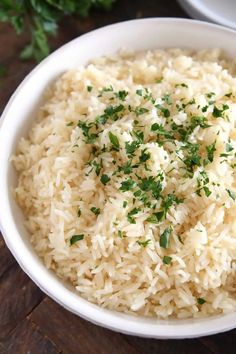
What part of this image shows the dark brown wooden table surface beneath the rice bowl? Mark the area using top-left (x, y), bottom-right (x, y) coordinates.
top-left (0, 0), bottom-right (236, 354)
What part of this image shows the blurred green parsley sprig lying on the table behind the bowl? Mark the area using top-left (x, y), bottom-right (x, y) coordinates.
top-left (0, 0), bottom-right (115, 61)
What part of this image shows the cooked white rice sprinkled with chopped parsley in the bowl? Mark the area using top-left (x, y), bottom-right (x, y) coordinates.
top-left (13, 50), bottom-right (236, 318)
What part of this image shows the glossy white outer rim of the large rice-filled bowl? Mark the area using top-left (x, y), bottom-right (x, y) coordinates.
top-left (0, 17), bottom-right (236, 339)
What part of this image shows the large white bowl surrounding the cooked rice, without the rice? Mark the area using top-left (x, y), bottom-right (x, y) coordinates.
top-left (0, 18), bottom-right (236, 338)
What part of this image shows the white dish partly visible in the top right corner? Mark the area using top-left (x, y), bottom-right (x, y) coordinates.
top-left (178, 0), bottom-right (236, 29)
